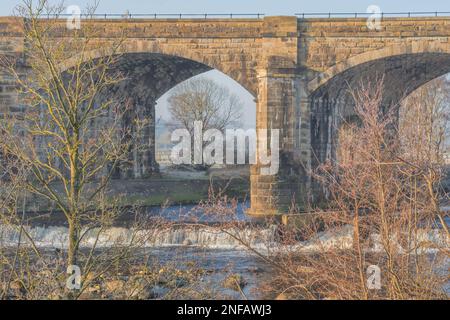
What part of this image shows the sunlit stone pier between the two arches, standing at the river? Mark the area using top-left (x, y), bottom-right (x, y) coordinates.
top-left (249, 66), bottom-right (305, 214)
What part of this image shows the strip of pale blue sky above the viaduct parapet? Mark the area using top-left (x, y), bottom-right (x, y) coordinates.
top-left (0, 0), bottom-right (450, 16)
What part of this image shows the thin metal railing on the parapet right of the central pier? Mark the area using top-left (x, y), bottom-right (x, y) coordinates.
top-left (295, 11), bottom-right (450, 19)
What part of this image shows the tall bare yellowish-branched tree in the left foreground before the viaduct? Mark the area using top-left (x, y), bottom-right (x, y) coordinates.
top-left (0, 0), bottom-right (142, 298)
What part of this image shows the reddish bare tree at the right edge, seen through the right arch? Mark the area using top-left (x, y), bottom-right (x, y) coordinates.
top-left (399, 76), bottom-right (450, 234)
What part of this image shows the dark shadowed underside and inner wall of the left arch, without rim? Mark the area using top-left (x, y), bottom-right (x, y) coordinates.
top-left (86, 52), bottom-right (256, 179)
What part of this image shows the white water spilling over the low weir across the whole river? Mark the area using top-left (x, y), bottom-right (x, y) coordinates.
top-left (0, 224), bottom-right (450, 253)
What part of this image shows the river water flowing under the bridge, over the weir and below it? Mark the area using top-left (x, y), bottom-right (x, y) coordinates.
top-left (0, 203), bottom-right (450, 299)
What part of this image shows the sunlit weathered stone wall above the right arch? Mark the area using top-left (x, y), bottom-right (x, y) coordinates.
top-left (298, 17), bottom-right (450, 72)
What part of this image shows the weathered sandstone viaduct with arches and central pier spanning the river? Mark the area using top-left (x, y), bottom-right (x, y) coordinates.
top-left (0, 16), bottom-right (450, 214)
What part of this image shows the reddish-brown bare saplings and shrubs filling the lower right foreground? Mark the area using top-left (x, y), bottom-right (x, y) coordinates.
top-left (206, 79), bottom-right (449, 299)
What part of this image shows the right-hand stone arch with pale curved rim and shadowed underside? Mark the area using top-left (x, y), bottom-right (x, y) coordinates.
top-left (308, 40), bottom-right (450, 179)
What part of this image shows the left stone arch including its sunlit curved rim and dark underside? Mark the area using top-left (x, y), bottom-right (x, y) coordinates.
top-left (59, 45), bottom-right (255, 179)
